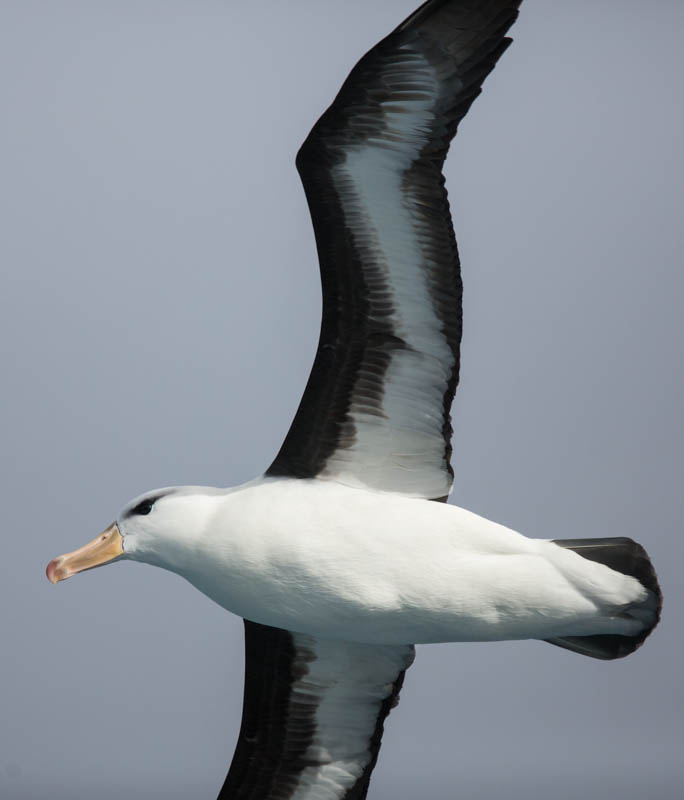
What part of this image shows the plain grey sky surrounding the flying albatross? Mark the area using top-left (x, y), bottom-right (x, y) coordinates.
top-left (0, 0), bottom-right (684, 800)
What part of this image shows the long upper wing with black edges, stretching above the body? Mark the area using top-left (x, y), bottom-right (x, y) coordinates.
top-left (267, 0), bottom-right (520, 499)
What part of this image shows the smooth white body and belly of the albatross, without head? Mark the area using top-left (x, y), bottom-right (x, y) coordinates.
top-left (176, 479), bottom-right (645, 644)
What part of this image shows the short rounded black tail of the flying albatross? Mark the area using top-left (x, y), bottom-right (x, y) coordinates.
top-left (546, 537), bottom-right (663, 659)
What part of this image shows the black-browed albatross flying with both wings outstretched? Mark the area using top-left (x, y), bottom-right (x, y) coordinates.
top-left (47, 0), bottom-right (661, 800)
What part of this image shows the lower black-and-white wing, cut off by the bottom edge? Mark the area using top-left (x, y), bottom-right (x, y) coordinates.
top-left (219, 621), bottom-right (413, 800)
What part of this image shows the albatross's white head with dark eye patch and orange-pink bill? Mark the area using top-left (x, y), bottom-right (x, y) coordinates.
top-left (45, 487), bottom-right (213, 583)
